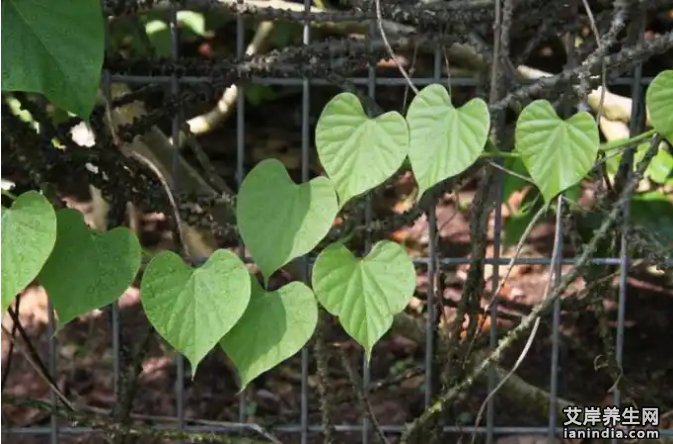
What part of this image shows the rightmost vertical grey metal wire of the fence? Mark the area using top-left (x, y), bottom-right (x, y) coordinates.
top-left (612, 12), bottom-right (645, 416)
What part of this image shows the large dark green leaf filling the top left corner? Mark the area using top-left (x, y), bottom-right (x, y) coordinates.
top-left (1, 0), bottom-right (104, 118)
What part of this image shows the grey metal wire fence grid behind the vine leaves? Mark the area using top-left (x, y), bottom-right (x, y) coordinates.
top-left (2, 0), bottom-right (673, 444)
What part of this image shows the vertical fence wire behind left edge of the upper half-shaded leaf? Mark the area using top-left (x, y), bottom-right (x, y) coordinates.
top-left (236, 0), bottom-right (247, 422)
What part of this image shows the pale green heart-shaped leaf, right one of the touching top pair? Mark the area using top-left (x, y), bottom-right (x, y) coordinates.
top-left (407, 84), bottom-right (490, 198)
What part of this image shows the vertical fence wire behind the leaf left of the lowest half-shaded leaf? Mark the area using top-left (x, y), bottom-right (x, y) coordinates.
top-left (169, 4), bottom-right (185, 436)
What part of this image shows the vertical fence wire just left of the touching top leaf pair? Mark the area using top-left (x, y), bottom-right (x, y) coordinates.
top-left (300, 0), bottom-right (312, 444)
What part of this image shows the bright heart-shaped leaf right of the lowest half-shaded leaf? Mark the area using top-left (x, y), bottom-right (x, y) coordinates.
top-left (313, 241), bottom-right (416, 359)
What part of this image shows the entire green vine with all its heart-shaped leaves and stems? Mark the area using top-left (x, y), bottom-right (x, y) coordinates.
top-left (2, 0), bottom-right (673, 442)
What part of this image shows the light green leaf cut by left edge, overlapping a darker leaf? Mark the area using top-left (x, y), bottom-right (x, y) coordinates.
top-left (2, 191), bottom-right (56, 313)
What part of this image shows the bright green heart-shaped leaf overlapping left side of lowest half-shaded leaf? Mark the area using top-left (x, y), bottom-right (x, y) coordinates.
top-left (140, 250), bottom-right (250, 375)
